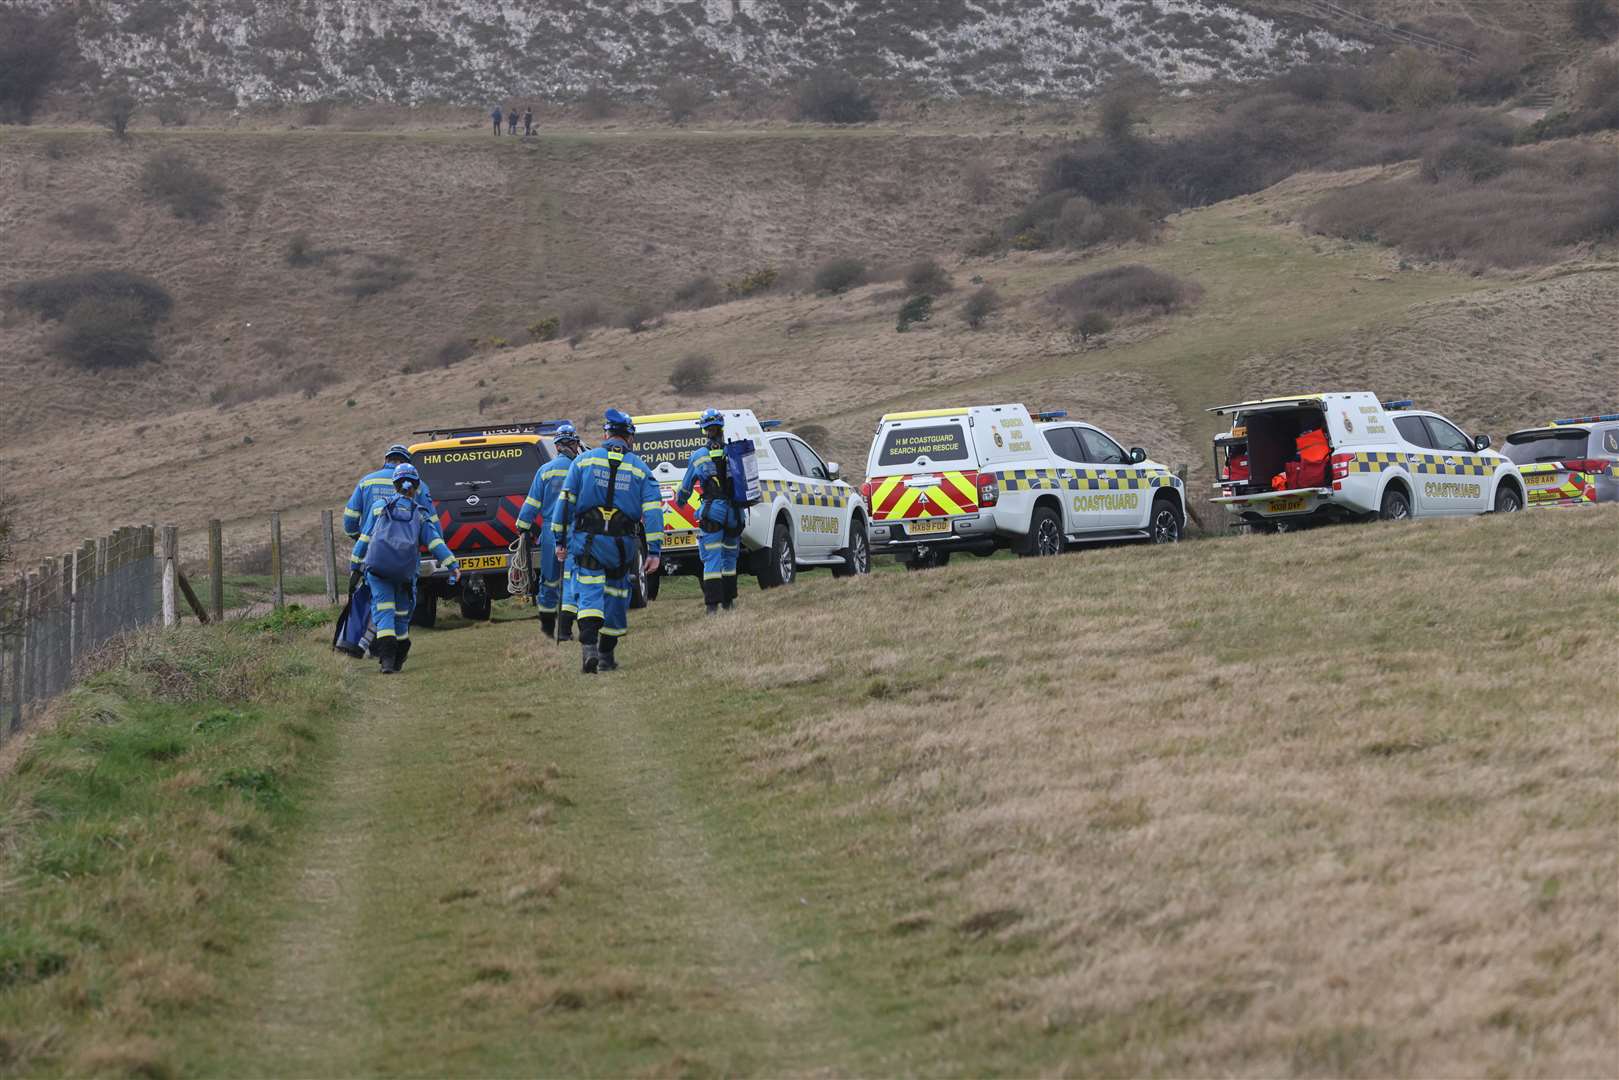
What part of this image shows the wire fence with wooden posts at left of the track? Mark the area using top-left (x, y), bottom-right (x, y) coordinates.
top-left (0, 510), bottom-right (346, 743)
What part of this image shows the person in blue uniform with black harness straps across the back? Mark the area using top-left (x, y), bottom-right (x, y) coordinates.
top-left (550, 408), bottom-right (664, 675)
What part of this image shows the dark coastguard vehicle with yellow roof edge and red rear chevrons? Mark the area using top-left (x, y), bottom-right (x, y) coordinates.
top-left (410, 421), bottom-right (562, 627)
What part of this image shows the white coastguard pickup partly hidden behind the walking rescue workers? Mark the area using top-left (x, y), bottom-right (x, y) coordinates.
top-left (635, 408), bottom-right (871, 597)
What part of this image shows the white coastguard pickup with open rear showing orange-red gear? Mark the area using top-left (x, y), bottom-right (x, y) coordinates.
top-left (1209, 393), bottom-right (1523, 533)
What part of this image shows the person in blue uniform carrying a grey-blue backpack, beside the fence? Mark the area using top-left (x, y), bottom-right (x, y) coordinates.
top-left (350, 463), bottom-right (460, 675)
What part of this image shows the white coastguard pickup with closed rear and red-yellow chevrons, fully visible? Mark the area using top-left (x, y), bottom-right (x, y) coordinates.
top-left (861, 405), bottom-right (1187, 568)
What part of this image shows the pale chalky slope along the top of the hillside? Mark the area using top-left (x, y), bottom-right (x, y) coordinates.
top-left (31, 0), bottom-right (1360, 102)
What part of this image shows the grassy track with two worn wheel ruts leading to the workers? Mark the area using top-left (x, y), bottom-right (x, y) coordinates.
top-left (176, 620), bottom-right (842, 1075)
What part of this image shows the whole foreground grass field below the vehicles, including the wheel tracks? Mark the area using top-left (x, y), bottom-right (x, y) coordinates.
top-left (0, 508), bottom-right (1619, 1077)
